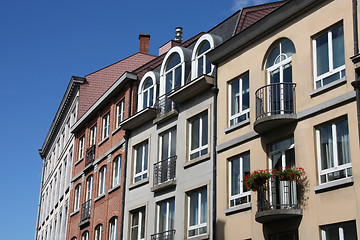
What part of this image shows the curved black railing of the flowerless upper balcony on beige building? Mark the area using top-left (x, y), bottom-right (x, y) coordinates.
top-left (255, 82), bottom-right (296, 120)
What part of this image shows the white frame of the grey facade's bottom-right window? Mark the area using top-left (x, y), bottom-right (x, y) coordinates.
top-left (187, 186), bottom-right (209, 238)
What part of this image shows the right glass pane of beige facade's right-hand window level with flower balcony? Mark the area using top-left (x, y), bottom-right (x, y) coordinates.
top-left (336, 120), bottom-right (350, 165)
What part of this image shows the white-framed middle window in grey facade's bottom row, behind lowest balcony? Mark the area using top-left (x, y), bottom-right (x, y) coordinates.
top-left (156, 198), bottom-right (175, 235)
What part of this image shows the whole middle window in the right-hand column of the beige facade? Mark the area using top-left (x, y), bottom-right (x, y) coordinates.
top-left (316, 119), bottom-right (352, 184)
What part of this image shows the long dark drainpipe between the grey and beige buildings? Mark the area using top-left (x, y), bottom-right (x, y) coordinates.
top-left (211, 65), bottom-right (219, 240)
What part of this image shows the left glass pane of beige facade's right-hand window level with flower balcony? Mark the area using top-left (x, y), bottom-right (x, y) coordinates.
top-left (320, 125), bottom-right (334, 170)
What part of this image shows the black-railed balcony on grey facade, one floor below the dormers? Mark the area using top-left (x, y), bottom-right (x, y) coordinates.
top-left (151, 156), bottom-right (177, 192)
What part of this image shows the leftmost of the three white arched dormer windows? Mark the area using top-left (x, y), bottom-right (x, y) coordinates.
top-left (138, 72), bottom-right (159, 111)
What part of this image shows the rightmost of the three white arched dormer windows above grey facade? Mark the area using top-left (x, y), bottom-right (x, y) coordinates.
top-left (191, 34), bottom-right (222, 80)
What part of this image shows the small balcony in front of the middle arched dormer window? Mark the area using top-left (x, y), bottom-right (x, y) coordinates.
top-left (153, 94), bottom-right (178, 124)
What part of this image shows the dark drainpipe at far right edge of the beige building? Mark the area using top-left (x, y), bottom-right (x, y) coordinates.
top-left (351, 0), bottom-right (360, 142)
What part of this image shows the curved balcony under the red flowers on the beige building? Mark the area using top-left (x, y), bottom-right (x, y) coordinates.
top-left (255, 178), bottom-right (302, 223)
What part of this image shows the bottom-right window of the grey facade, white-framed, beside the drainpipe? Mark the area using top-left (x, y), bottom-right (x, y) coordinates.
top-left (187, 187), bottom-right (208, 237)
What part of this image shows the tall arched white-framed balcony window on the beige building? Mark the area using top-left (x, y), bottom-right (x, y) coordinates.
top-left (265, 38), bottom-right (295, 114)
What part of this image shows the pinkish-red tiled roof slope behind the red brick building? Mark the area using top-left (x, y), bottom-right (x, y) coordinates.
top-left (78, 53), bottom-right (156, 118)
